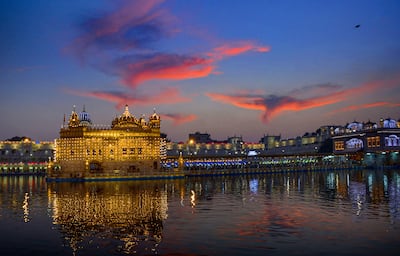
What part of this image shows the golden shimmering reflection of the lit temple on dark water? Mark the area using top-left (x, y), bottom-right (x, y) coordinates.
top-left (48, 182), bottom-right (180, 254)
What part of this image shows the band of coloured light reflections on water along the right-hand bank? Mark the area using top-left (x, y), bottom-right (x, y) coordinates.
top-left (180, 170), bottom-right (400, 220)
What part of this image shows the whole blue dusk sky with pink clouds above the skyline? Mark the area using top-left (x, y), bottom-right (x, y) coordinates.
top-left (0, 0), bottom-right (400, 142)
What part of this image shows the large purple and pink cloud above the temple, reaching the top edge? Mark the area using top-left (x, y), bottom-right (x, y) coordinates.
top-left (69, 0), bottom-right (270, 88)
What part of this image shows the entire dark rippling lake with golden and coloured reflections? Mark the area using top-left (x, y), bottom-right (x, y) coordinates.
top-left (0, 170), bottom-right (400, 255)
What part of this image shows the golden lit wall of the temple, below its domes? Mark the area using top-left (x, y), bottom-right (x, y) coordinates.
top-left (55, 127), bottom-right (160, 177)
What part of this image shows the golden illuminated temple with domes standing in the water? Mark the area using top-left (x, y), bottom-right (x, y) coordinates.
top-left (49, 105), bottom-right (161, 178)
